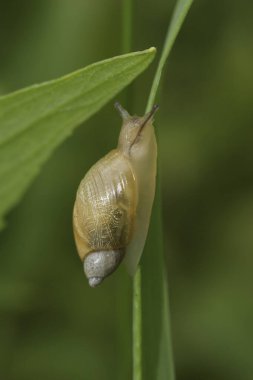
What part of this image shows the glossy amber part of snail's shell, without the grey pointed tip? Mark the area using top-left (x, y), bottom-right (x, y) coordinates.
top-left (73, 149), bottom-right (137, 260)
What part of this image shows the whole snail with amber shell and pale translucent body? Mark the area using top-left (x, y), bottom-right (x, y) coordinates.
top-left (73, 103), bottom-right (158, 287)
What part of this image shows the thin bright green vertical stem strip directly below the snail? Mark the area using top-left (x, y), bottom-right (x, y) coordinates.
top-left (133, 266), bottom-right (142, 380)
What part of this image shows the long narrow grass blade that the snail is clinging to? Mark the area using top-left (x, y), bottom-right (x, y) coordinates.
top-left (136, 0), bottom-right (193, 380)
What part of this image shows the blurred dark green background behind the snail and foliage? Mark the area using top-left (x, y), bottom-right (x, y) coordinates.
top-left (0, 0), bottom-right (253, 380)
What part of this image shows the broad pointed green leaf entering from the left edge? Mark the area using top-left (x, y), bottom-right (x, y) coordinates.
top-left (0, 48), bottom-right (155, 228)
